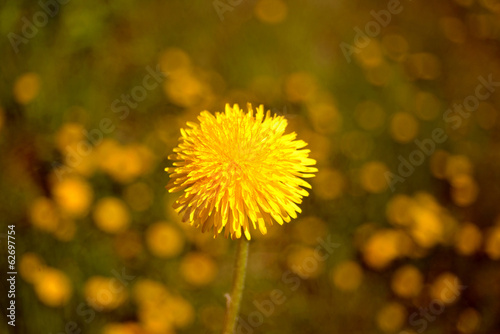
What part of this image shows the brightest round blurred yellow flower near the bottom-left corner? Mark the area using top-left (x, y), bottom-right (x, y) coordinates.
top-left (35, 268), bottom-right (72, 307)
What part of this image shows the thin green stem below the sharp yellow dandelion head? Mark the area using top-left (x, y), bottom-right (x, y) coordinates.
top-left (223, 236), bottom-right (250, 334)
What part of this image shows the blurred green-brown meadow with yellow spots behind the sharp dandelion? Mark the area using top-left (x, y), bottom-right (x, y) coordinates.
top-left (0, 0), bottom-right (500, 334)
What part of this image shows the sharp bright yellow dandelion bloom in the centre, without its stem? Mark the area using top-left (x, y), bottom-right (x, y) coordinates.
top-left (165, 104), bottom-right (318, 239)
